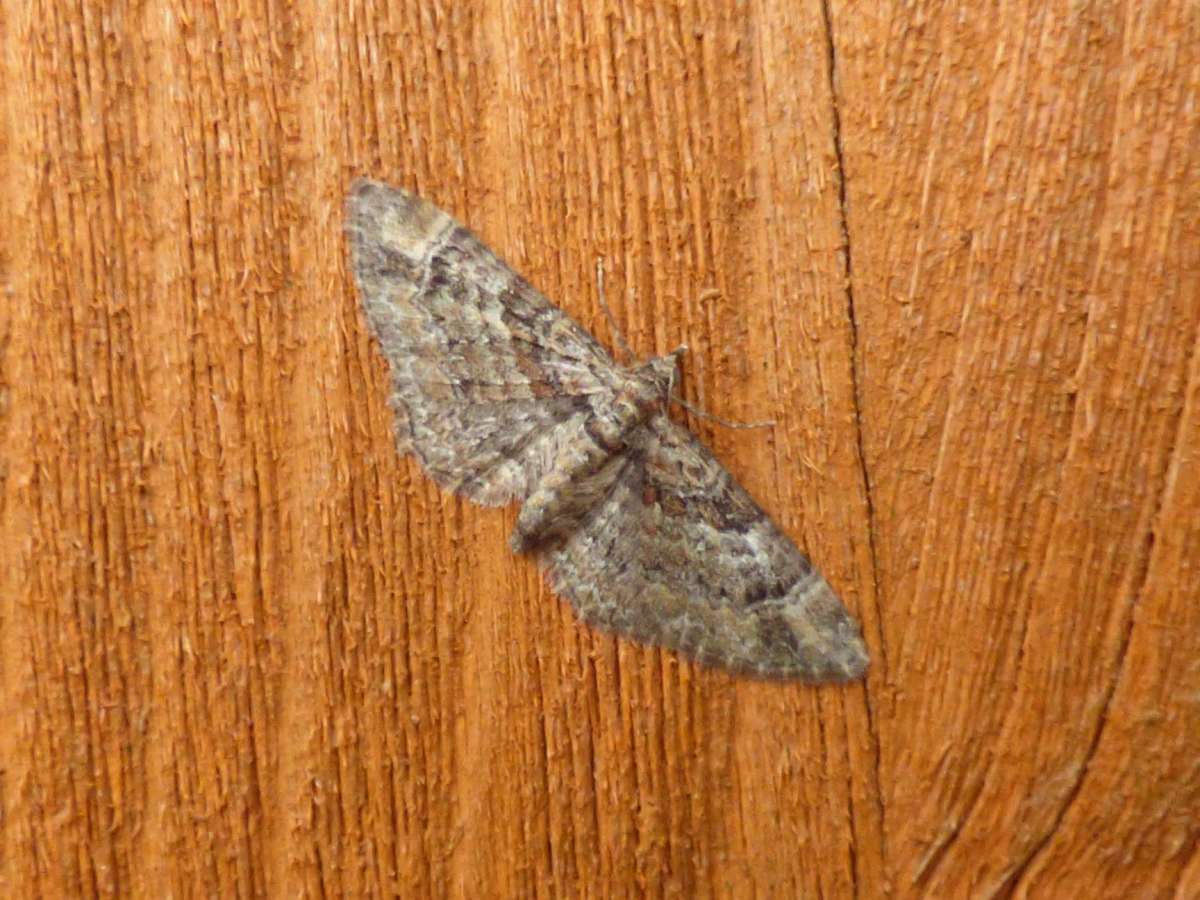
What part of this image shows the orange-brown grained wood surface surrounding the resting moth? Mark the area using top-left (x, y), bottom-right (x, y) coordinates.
top-left (0, 0), bottom-right (1200, 898)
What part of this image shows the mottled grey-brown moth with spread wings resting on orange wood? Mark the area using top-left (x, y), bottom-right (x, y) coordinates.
top-left (346, 180), bottom-right (868, 682)
